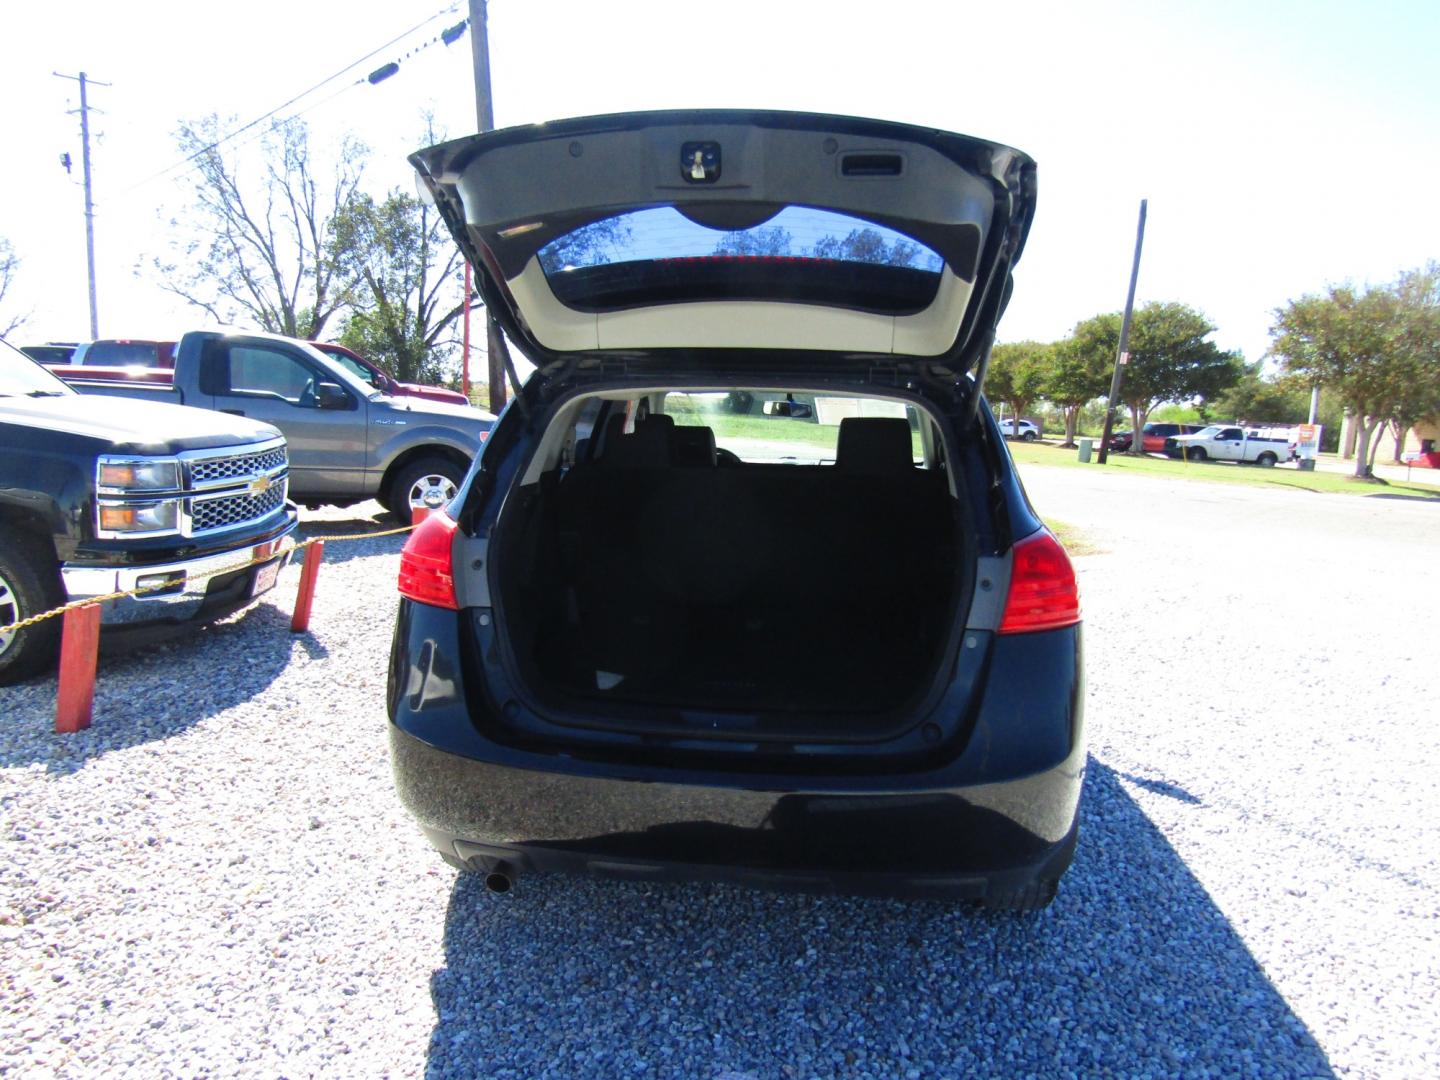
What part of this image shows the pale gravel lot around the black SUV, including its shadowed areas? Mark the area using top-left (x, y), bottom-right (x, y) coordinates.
top-left (0, 478), bottom-right (1440, 1080)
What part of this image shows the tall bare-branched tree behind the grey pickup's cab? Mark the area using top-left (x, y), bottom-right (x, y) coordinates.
top-left (153, 115), bottom-right (367, 338)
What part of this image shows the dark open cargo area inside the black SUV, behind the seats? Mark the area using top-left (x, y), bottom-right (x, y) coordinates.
top-left (498, 399), bottom-right (965, 734)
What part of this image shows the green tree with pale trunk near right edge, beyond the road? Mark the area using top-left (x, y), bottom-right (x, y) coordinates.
top-left (1270, 285), bottom-right (1414, 477)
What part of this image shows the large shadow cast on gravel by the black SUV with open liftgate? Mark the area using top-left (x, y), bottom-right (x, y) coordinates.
top-left (428, 759), bottom-right (1333, 1080)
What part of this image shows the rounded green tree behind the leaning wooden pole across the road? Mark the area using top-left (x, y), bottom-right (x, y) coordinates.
top-left (1073, 301), bottom-right (1243, 454)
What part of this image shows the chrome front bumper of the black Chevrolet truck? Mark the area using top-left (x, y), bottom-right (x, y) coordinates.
top-left (60, 508), bottom-right (298, 626)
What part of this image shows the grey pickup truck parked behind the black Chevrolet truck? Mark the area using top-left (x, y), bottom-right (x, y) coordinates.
top-left (50, 331), bottom-right (495, 520)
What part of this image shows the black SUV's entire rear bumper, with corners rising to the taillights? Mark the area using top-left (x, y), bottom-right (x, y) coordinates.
top-left (387, 602), bottom-right (1086, 899)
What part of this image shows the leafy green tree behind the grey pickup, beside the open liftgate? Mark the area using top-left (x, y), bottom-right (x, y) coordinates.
top-left (331, 190), bottom-right (465, 383)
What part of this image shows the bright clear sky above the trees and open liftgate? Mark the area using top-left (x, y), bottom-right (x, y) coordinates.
top-left (0, 0), bottom-right (1440, 359)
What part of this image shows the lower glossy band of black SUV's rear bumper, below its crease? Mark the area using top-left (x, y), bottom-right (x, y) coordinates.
top-left (390, 726), bottom-right (1081, 900)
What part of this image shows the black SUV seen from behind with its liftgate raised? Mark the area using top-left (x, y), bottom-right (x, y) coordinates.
top-left (387, 111), bottom-right (1086, 909)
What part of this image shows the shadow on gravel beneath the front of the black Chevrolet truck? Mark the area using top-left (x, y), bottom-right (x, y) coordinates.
top-left (0, 600), bottom-right (299, 773)
